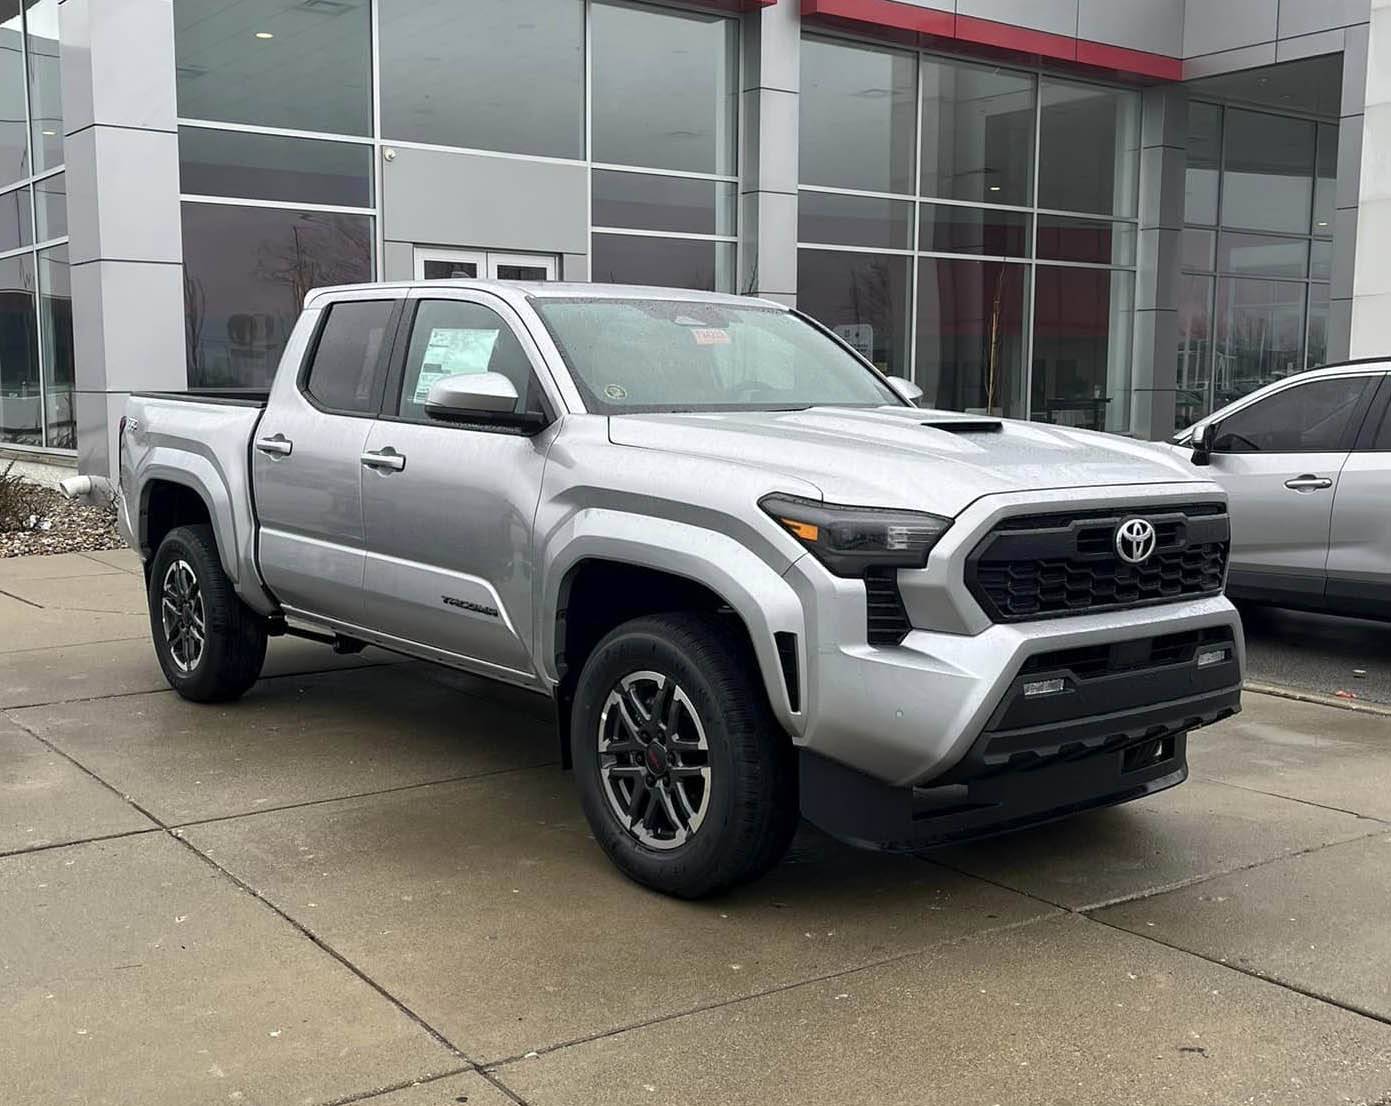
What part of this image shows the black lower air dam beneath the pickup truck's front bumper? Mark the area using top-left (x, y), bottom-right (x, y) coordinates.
top-left (800, 687), bottom-right (1241, 851)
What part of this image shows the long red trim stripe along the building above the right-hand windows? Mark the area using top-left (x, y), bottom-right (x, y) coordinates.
top-left (801, 0), bottom-right (1182, 81)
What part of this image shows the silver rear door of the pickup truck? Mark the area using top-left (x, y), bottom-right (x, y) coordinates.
top-left (252, 292), bottom-right (402, 625)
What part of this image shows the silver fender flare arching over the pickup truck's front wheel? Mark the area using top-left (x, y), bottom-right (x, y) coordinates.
top-left (536, 508), bottom-right (808, 739)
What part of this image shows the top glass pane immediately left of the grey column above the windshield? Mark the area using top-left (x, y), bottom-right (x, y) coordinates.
top-left (589, 0), bottom-right (739, 175)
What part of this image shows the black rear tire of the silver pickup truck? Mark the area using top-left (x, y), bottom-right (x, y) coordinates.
top-left (146, 526), bottom-right (266, 703)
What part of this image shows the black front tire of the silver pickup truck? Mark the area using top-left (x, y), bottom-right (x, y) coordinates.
top-left (570, 612), bottom-right (798, 899)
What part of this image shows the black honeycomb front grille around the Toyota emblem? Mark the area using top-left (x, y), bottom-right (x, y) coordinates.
top-left (967, 504), bottom-right (1231, 622)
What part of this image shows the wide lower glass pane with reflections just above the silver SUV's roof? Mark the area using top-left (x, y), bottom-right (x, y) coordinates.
top-left (1213, 277), bottom-right (1308, 409)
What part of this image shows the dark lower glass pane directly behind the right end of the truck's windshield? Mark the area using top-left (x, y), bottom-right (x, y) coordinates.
top-left (797, 249), bottom-right (912, 376)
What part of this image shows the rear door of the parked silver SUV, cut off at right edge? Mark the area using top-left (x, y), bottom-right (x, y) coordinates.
top-left (1327, 377), bottom-right (1391, 618)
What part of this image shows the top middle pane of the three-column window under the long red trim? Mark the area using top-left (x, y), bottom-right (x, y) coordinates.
top-left (922, 58), bottom-right (1035, 205)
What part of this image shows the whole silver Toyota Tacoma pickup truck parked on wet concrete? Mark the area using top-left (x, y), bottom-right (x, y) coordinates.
top-left (111, 281), bottom-right (1244, 896)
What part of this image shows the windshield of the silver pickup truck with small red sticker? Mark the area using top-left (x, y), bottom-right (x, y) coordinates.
top-left (533, 298), bottom-right (903, 415)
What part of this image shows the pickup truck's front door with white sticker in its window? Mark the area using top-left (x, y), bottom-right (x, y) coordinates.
top-left (362, 288), bottom-right (555, 683)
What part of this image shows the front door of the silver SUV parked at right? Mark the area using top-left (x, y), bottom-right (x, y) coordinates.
top-left (1210, 374), bottom-right (1377, 604)
